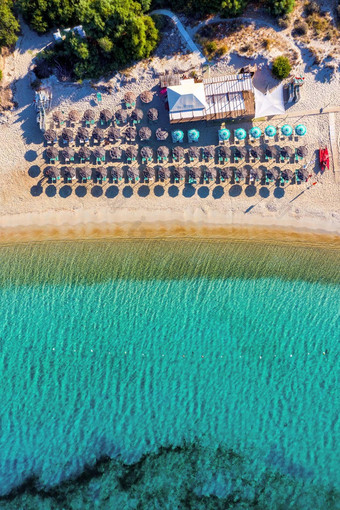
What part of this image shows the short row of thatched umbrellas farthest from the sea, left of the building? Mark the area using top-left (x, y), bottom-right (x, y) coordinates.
top-left (52, 108), bottom-right (159, 123)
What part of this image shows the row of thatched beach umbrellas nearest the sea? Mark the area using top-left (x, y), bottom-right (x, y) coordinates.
top-left (44, 166), bottom-right (308, 180)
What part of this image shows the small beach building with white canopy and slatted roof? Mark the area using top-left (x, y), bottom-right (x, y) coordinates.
top-left (167, 72), bottom-right (255, 123)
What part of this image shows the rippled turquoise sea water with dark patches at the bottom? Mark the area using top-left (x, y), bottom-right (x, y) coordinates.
top-left (0, 241), bottom-right (340, 509)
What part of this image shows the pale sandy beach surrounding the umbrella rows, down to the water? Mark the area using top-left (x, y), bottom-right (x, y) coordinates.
top-left (0, 18), bottom-right (340, 241)
